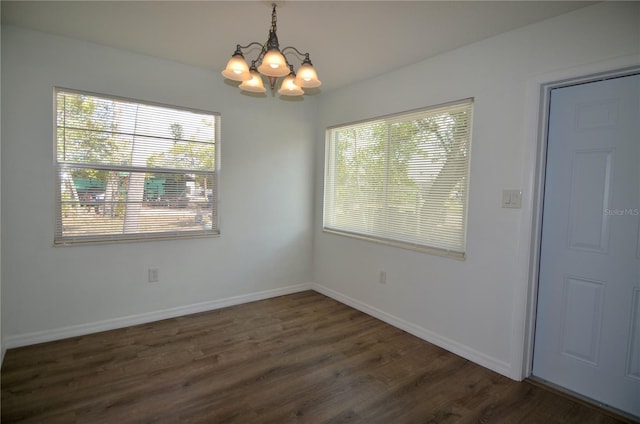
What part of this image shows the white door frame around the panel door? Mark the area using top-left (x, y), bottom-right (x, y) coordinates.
top-left (511, 55), bottom-right (640, 380)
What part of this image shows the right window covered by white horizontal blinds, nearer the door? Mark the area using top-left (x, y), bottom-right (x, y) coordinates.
top-left (324, 100), bottom-right (473, 259)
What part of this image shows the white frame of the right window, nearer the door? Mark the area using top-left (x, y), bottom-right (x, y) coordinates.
top-left (322, 97), bottom-right (475, 260)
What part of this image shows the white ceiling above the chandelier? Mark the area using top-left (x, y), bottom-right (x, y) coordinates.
top-left (1, 1), bottom-right (593, 91)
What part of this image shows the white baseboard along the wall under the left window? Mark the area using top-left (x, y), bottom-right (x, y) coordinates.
top-left (2, 283), bottom-right (312, 349)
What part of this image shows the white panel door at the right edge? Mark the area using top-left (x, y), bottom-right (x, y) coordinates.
top-left (533, 75), bottom-right (640, 417)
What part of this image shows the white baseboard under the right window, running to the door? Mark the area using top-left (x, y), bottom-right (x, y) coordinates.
top-left (312, 283), bottom-right (512, 379)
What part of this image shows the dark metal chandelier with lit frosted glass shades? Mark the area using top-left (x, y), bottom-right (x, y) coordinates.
top-left (222, 3), bottom-right (322, 96)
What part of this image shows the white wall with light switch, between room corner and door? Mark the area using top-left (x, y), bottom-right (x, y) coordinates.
top-left (314, 2), bottom-right (640, 379)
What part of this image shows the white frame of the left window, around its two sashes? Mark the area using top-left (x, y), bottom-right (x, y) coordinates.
top-left (53, 86), bottom-right (221, 247)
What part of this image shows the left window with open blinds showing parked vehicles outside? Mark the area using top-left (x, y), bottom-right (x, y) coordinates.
top-left (54, 89), bottom-right (220, 245)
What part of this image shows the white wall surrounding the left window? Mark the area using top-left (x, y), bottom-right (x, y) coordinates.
top-left (1, 26), bottom-right (316, 347)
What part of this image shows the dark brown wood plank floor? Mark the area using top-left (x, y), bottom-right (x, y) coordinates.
top-left (1, 291), bottom-right (636, 424)
